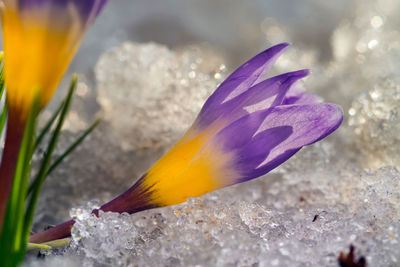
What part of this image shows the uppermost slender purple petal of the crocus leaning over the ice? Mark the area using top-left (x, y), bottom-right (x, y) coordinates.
top-left (199, 43), bottom-right (289, 127)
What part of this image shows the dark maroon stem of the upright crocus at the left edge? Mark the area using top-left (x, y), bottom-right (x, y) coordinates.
top-left (0, 112), bottom-right (25, 232)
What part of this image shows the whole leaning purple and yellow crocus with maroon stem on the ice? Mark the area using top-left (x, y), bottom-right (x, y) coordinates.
top-left (31, 43), bottom-right (343, 245)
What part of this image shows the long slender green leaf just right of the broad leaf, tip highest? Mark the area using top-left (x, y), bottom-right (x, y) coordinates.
top-left (24, 75), bottom-right (77, 249)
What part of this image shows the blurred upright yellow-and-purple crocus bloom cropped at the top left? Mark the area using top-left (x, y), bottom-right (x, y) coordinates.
top-left (1, 0), bottom-right (106, 120)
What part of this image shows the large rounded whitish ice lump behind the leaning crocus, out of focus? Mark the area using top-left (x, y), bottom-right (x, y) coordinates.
top-left (96, 43), bottom-right (225, 150)
